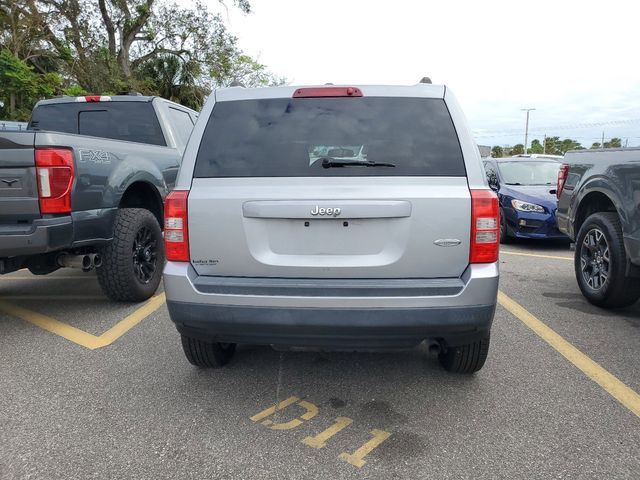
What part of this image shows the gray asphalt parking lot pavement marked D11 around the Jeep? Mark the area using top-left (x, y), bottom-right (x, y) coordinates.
top-left (0, 249), bottom-right (640, 479)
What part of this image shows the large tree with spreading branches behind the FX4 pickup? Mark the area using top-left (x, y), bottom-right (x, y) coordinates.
top-left (0, 0), bottom-right (284, 113)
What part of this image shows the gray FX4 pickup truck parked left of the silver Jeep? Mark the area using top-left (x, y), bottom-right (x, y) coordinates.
top-left (0, 95), bottom-right (197, 301)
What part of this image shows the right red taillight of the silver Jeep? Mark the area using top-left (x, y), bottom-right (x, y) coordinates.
top-left (469, 190), bottom-right (500, 263)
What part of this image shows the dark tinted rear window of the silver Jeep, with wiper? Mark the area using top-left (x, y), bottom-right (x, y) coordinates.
top-left (194, 97), bottom-right (465, 178)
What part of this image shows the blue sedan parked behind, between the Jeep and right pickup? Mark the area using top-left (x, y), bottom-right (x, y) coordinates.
top-left (484, 157), bottom-right (569, 243)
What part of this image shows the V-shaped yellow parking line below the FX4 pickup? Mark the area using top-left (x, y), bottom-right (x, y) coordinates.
top-left (0, 293), bottom-right (165, 350)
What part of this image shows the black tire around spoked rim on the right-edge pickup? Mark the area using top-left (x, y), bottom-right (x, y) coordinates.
top-left (574, 212), bottom-right (640, 308)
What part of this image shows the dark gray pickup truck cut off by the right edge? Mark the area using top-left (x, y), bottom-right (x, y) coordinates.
top-left (557, 148), bottom-right (640, 308)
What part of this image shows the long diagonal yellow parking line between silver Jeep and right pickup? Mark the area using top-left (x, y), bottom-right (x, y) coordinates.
top-left (498, 292), bottom-right (640, 417)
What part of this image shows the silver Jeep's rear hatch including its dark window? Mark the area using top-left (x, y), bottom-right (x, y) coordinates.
top-left (188, 93), bottom-right (471, 278)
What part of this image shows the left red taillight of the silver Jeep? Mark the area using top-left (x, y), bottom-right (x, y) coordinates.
top-left (164, 190), bottom-right (189, 262)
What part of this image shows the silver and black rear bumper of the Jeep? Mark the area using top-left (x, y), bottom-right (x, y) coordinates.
top-left (164, 262), bottom-right (498, 348)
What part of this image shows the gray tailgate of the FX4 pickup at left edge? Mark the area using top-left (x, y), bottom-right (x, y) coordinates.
top-left (0, 132), bottom-right (40, 229)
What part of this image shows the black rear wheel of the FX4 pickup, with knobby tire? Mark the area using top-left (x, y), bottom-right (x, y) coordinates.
top-left (96, 208), bottom-right (164, 302)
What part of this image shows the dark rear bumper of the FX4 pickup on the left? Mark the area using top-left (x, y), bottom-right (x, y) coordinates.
top-left (0, 216), bottom-right (73, 258)
